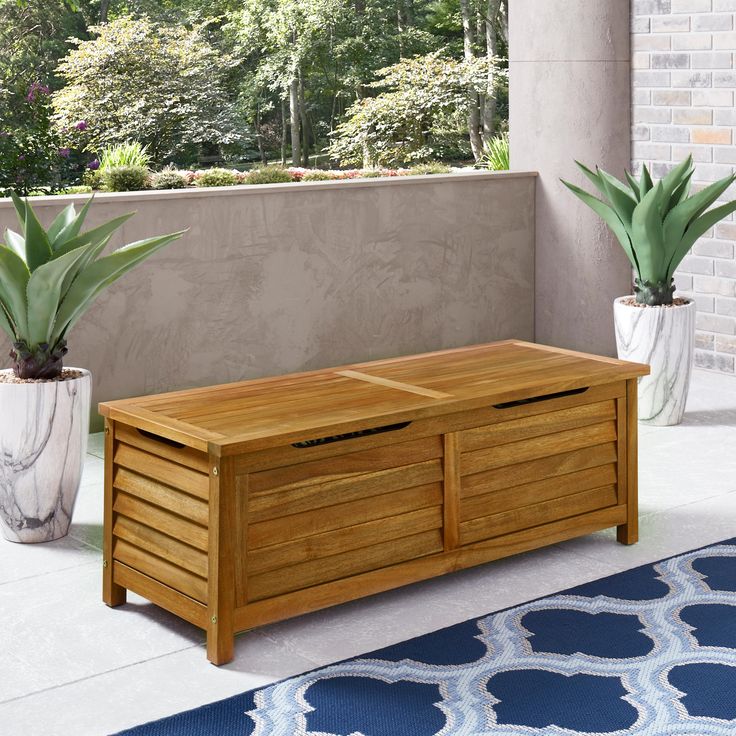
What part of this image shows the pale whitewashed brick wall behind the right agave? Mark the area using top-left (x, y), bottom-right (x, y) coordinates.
top-left (631, 0), bottom-right (736, 373)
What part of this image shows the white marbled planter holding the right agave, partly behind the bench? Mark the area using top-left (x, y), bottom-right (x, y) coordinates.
top-left (613, 297), bottom-right (695, 425)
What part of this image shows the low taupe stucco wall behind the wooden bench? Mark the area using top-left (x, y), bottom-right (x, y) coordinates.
top-left (0, 172), bottom-right (535, 428)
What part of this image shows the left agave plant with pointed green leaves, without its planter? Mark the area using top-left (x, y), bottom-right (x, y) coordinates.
top-left (0, 193), bottom-right (183, 379)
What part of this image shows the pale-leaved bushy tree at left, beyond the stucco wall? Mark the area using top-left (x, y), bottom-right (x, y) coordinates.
top-left (53, 16), bottom-right (246, 162)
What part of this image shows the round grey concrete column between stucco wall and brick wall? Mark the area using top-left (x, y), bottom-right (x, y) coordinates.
top-left (509, 0), bottom-right (631, 355)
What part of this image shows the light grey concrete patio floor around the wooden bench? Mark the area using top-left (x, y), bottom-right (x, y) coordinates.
top-left (0, 371), bottom-right (736, 736)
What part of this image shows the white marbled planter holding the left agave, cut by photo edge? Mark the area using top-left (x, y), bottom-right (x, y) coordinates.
top-left (0, 371), bottom-right (92, 542)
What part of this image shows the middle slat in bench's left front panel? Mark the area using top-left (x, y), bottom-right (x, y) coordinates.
top-left (248, 483), bottom-right (442, 550)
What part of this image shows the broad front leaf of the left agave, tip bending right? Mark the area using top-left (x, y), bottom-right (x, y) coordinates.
top-left (26, 243), bottom-right (92, 345)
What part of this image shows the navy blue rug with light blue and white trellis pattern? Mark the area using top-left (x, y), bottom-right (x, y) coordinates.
top-left (118, 539), bottom-right (736, 736)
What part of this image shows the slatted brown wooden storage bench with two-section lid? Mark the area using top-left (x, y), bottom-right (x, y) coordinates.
top-left (100, 341), bottom-right (649, 664)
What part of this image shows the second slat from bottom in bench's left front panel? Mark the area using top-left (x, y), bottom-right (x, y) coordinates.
top-left (248, 506), bottom-right (442, 575)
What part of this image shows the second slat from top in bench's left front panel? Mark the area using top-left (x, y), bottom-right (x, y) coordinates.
top-left (248, 460), bottom-right (443, 523)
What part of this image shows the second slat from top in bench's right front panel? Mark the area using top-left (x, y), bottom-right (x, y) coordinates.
top-left (460, 422), bottom-right (616, 475)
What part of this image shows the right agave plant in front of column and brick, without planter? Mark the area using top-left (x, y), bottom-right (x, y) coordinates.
top-left (562, 156), bottom-right (736, 306)
